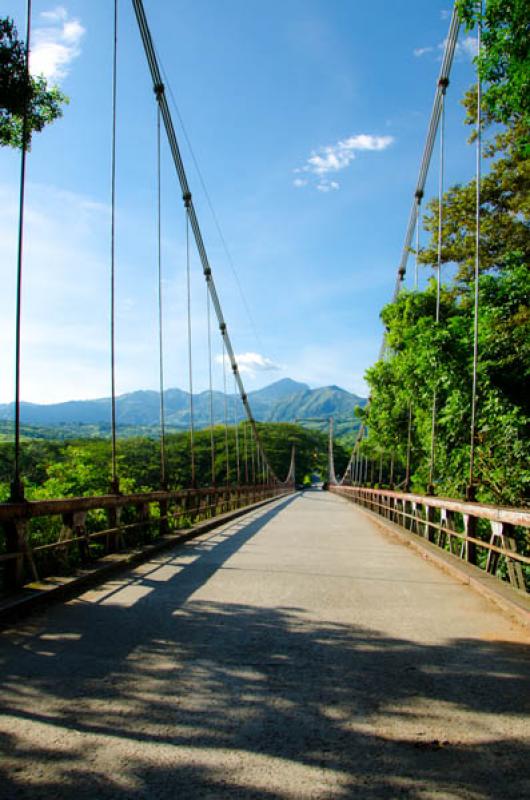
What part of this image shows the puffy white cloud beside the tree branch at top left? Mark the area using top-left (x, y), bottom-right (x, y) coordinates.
top-left (30, 6), bottom-right (85, 82)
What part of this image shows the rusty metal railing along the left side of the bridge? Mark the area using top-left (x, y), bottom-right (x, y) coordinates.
top-left (0, 485), bottom-right (294, 591)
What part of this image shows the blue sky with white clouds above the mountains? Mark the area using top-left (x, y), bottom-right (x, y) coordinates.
top-left (0, 0), bottom-right (474, 402)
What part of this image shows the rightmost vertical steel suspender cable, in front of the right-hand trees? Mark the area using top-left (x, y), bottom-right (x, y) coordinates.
top-left (467, 10), bottom-right (483, 500)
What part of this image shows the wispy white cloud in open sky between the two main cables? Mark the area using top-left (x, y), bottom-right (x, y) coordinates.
top-left (293, 133), bottom-right (394, 192)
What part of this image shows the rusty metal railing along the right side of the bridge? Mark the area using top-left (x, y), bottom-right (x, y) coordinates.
top-left (329, 486), bottom-right (530, 593)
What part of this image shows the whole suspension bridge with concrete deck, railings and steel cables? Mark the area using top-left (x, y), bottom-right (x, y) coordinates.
top-left (0, 0), bottom-right (530, 800)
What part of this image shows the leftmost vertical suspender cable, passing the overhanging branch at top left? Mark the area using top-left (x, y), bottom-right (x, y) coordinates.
top-left (11, 0), bottom-right (31, 502)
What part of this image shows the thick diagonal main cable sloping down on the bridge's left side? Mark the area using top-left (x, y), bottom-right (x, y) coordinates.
top-left (132, 0), bottom-right (279, 482)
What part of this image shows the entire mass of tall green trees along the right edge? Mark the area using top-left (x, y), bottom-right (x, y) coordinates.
top-left (360, 0), bottom-right (530, 504)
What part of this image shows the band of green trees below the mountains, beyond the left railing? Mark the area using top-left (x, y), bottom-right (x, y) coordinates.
top-left (0, 423), bottom-right (348, 500)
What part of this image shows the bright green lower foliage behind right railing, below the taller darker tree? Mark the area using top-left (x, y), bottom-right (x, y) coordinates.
top-left (358, 264), bottom-right (530, 504)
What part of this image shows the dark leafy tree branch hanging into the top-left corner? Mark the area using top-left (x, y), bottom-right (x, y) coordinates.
top-left (0, 17), bottom-right (68, 149)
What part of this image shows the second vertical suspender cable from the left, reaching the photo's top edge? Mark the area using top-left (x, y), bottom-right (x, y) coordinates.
top-left (110, 0), bottom-right (120, 493)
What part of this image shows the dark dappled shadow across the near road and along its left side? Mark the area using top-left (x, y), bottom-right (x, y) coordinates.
top-left (0, 490), bottom-right (530, 800)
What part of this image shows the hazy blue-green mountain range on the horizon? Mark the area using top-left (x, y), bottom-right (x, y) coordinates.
top-left (0, 378), bottom-right (366, 429)
